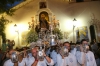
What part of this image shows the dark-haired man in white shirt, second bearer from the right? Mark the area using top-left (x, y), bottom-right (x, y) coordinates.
top-left (57, 42), bottom-right (77, 66)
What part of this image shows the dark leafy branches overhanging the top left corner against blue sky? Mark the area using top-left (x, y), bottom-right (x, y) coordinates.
top-left (0, 0), bottom-right (23, 16)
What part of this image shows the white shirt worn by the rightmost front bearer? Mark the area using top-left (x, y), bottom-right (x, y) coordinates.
top-left (76, 51), bottom-right (97, 66)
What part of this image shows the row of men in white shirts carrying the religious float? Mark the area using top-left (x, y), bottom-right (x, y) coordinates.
top-left (0, 39), bottom-right (100, 66)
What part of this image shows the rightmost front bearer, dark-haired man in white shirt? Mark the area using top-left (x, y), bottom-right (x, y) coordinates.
top-left (76, 39), bottom-right (97, 66)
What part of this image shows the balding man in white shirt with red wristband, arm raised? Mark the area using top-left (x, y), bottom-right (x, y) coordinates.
top-left (27, 48), bottom-right (54, 66)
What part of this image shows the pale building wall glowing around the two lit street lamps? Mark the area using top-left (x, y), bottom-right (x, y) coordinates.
top-left (6, 0), bottom-right (100, 46)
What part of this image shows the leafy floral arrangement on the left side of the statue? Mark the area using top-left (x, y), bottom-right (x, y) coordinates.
top-left (26, 29), bottom-right (38, 43)
